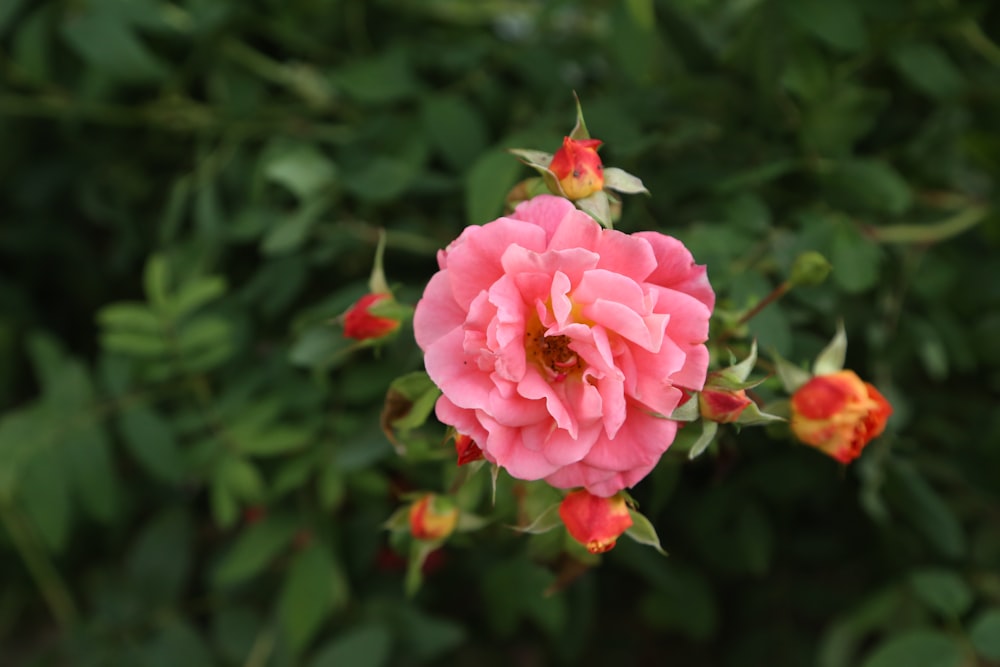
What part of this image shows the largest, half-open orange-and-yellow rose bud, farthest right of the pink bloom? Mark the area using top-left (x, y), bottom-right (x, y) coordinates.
top-left (791, 370), bottom-right (892, 463)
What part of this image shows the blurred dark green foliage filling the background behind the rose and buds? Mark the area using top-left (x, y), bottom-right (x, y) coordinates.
top-left (0, 0), bottom-right (1000, 667)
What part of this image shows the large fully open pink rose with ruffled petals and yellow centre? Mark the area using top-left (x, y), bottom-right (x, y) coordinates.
top-left (413, 195), bottom-right (715, 497)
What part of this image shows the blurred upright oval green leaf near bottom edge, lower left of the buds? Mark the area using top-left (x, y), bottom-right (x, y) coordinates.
top-left (278, 543), bottom-right (343, 651)
